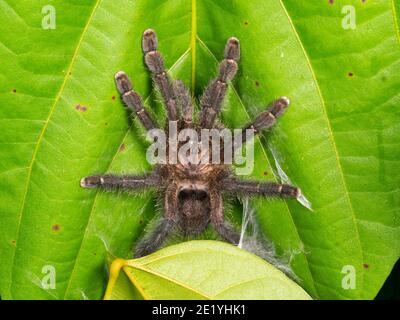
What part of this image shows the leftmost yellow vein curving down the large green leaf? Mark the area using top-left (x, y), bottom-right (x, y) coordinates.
top-left (9, 0), bottom-right (102, 298)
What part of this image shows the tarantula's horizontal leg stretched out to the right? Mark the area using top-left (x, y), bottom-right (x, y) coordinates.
top-left (221, 178), bottom-right (301, 198)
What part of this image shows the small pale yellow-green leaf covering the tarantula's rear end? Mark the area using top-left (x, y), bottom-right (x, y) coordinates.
top-left (104, 240), bottom-right (311, 300)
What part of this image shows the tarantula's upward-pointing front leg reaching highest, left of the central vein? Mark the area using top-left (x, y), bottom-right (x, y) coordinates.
top-left (142, 29), bottom-right (178, 121)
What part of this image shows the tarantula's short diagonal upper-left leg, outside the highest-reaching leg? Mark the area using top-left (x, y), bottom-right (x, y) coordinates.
top-left (115, 71), bottom-right (156, 130)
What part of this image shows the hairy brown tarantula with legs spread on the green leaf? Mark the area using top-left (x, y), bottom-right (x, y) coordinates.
top-left (81, 29), bottom-right (300, 257)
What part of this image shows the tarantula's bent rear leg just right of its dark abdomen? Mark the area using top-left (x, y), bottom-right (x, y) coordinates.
top-left (210, 192), bottom-right (240, 245)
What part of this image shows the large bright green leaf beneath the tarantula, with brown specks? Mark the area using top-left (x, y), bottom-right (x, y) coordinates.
top-left (0, 0), bottom-right (400, 299)
